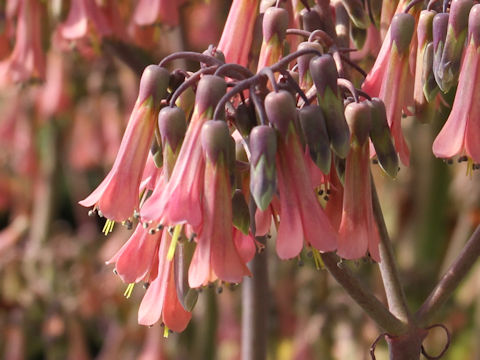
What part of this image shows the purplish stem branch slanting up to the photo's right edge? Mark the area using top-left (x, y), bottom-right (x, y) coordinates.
top-left (415, 225), bottom-right (480, 325)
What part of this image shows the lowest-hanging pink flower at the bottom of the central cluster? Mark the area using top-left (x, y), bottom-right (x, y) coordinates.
top-left (138, 231), bottom-right (192, 332)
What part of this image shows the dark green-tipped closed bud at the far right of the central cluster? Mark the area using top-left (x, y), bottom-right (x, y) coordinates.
top-left (369, 98), bottom-right (398, 178)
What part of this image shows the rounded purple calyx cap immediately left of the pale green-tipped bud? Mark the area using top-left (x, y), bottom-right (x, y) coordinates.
top-left (200, 120), bottom-right (235, 166)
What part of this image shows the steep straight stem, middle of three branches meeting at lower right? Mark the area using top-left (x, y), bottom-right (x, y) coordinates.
top-left (371, 177), bottom-right (412, 322)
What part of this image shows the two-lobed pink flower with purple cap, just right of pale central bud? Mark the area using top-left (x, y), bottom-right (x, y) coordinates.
top-left (265, 91), bottom-right (337, 259)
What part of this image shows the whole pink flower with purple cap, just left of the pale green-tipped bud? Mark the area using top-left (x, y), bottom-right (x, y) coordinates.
top-left (188, 120), bottom-right (251, 288)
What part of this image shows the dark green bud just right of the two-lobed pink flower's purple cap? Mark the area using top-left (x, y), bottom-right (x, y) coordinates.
top-left (298, 105), bottom-right (332, 174)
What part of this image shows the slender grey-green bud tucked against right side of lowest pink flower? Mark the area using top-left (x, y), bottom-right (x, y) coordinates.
top-left (173, 238), bottom-right (198, 312)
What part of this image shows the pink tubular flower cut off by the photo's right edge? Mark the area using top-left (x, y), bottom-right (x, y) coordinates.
top-left (433, 5), bottom-right (480, 163)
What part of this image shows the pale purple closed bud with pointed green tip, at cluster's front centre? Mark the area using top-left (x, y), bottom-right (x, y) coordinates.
top-left (250, 125), bottom-right (277, 210)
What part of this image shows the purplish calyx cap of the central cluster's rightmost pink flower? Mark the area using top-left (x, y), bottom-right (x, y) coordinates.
top-left (345, 101), bottom-right (372, 146)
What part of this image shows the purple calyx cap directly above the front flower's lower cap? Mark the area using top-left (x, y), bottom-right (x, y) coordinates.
top-left (195, 75), bottom-right (227, 116)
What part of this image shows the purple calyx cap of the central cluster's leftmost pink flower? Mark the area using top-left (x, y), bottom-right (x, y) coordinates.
top-left (137, 65), bottom-right (170, 109)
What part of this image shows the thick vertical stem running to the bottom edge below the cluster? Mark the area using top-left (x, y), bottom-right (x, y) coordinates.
top-left (242, 242), bottom-right (268, 360)
